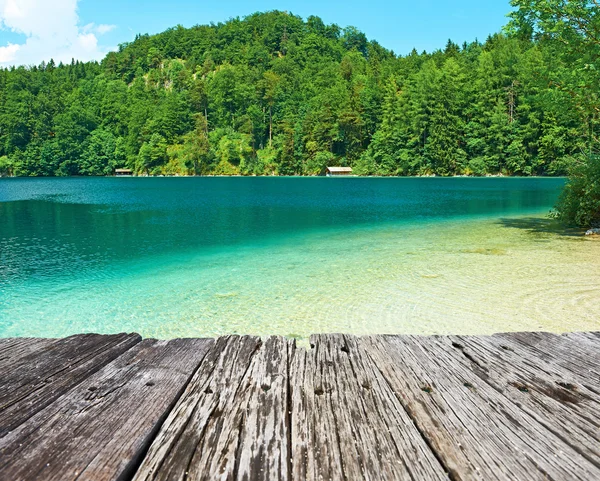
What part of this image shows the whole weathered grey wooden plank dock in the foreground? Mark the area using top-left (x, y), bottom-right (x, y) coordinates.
top-left (0, 333), bottom-right (600, 481)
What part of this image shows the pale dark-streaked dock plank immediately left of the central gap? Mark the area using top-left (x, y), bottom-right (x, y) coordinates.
top-left (134, 336), bottom-right (288, 481)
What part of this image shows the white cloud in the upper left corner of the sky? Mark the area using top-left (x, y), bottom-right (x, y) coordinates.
top-left (0, 0), bottom-right (114, 66)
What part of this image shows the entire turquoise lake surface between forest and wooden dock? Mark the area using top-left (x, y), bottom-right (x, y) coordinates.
top-left (0, 178), bottom-right (600, 338)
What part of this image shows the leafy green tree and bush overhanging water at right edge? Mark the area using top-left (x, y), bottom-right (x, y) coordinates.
top-left (510, 0), bottom-right (600, 226)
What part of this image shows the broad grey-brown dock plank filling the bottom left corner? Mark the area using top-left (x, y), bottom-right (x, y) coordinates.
top-left (0, 339), bottom-right (214, 481)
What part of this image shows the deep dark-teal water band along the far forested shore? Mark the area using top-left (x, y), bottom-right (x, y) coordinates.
top-left (0, 178), bottom-right (563, 283)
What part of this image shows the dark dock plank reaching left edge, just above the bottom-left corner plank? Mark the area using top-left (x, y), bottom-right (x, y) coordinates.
top-left (0, 334), bottom-right (141, 437)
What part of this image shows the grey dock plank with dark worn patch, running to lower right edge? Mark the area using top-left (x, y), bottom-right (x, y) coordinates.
top-left (442, 336), bottom-right (600, 465)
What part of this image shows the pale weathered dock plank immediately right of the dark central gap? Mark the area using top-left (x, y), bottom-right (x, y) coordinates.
top-left (290, 335), bottom-right (448, 480)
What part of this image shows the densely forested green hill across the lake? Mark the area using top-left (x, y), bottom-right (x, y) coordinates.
top-left (0, 11), bottom-right (590, 175)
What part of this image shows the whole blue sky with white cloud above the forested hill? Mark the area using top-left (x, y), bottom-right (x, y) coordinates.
top-left (0, 0), bottom-right (511, 66)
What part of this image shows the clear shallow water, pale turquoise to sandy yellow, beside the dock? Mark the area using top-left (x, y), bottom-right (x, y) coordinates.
top-left (0, 214), bottom-right (600, 338)
